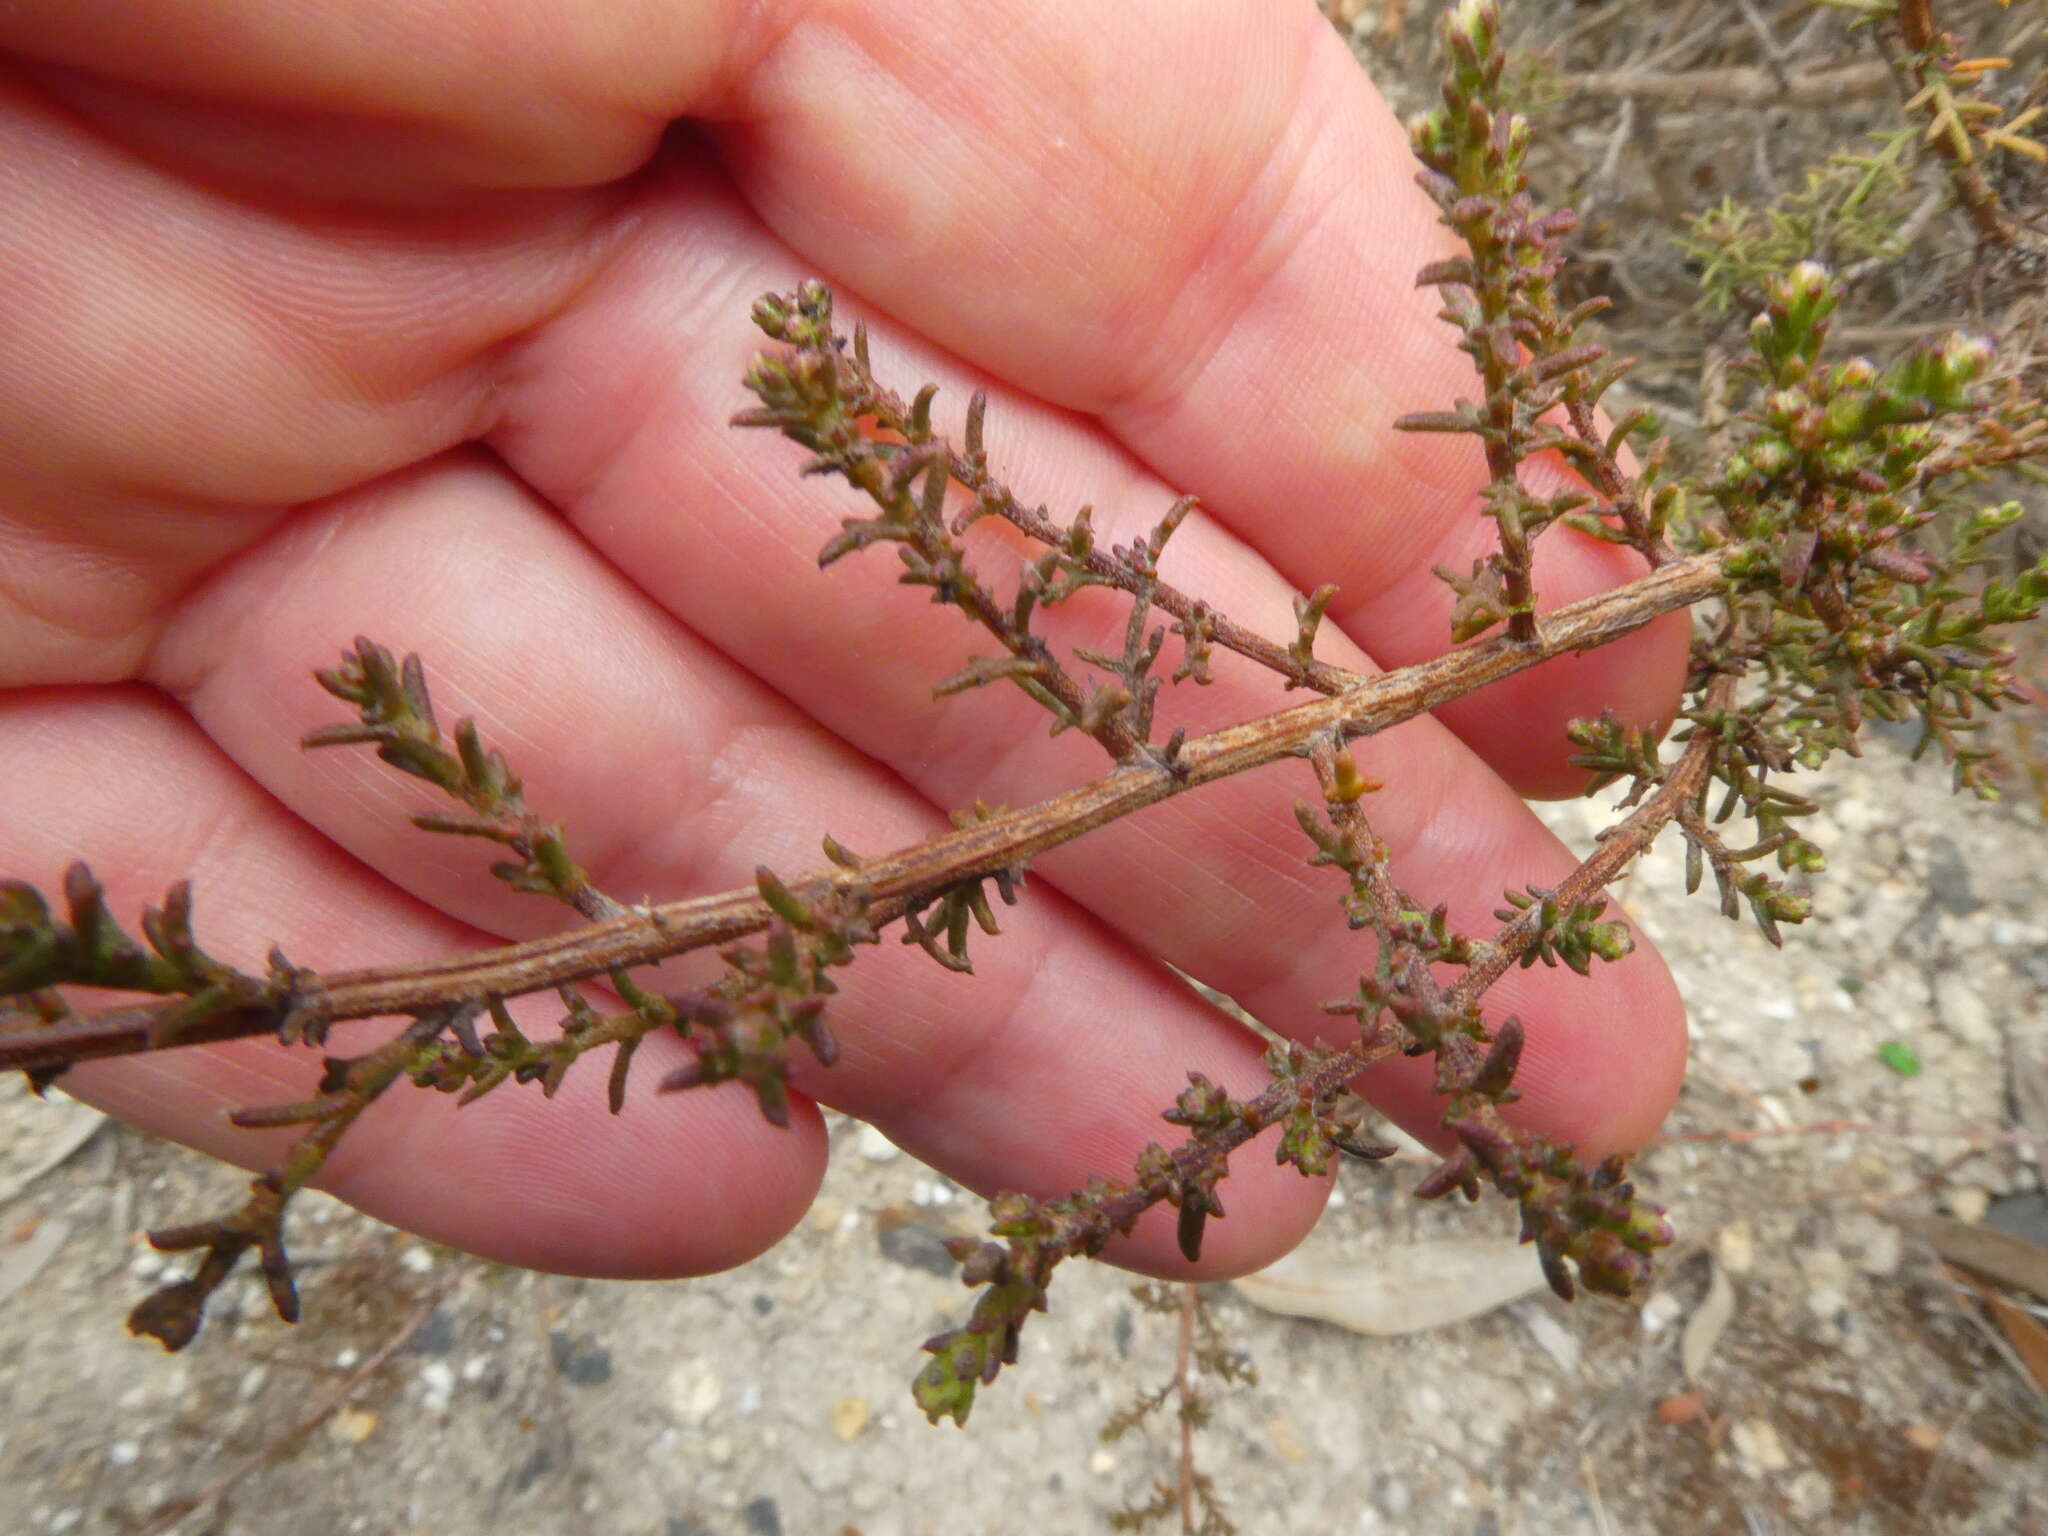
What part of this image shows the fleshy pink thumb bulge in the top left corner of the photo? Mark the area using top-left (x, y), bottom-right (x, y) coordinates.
top-left (0, 0), bottom-right (724, 205)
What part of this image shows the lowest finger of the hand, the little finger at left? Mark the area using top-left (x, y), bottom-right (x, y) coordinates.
top-left (0, 688), bottom-right (825, 1278)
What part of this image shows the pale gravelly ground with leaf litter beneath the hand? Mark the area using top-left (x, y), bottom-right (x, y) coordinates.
top-left (0, 743), bottom-right (2048, 1536)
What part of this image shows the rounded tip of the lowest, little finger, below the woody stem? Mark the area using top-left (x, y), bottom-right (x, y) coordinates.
top-left (66, 1040), bottom-right (825, 1280)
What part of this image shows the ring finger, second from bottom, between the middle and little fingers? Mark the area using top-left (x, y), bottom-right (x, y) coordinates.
top-left (152, 457), bottom-right (1323, 1274)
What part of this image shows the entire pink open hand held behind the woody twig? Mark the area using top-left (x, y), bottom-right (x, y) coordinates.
top-left (0, 0), bottom-right (1686, 1302)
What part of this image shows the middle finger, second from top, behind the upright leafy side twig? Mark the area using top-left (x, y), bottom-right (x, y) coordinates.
top-left (475, 166), bottom-right (1683, 1149)
